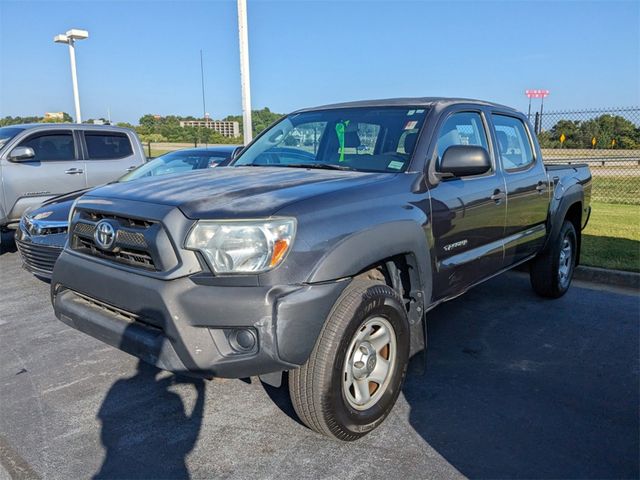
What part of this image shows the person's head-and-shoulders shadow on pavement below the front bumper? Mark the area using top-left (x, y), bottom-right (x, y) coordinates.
top-left (95, 320), bottom-right (205, 479)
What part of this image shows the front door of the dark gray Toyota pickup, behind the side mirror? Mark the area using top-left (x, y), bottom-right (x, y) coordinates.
top-left (431, 111), bottom-right (506, 299)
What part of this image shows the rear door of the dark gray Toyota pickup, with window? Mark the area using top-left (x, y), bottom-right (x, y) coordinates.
top-left (491, 111), bottom-right (550, 266)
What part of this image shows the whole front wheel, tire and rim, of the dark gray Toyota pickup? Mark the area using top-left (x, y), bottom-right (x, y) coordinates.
top-left (289, 280), bottom-right (409, 441)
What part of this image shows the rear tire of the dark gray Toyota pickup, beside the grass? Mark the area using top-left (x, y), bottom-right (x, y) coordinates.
top-left (529, 220), bottom-right (578, 298)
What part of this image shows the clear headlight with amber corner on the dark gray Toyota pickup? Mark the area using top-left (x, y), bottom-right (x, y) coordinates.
top-left (185, 218), bottom-right (296, 273)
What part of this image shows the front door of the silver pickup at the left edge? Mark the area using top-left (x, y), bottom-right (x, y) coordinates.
top-left (2, 130), bottom-right (86, 221)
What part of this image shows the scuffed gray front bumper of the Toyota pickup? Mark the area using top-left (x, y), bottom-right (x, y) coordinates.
top-left (51, 251), bottom-right (349, 378)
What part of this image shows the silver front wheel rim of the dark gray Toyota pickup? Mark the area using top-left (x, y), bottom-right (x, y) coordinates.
top-left (342, 317), bottom-right (398, 410)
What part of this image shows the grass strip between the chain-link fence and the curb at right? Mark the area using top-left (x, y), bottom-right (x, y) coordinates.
top-left (580, 203), bottom-right (640, 272)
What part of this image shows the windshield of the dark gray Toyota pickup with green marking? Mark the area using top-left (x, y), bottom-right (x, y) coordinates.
top-left (233, 107), bottom-right (426, 173)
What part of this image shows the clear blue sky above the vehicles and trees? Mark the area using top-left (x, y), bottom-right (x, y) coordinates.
top-left (0, 0), bottom-right (640, 123)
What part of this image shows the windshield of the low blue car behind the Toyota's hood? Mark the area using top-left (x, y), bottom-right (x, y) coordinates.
top-left (118, 150), bottom-right (231, 182)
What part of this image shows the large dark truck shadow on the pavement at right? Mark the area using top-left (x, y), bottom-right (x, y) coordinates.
top-left (404, 274), bottom-right (640, 478)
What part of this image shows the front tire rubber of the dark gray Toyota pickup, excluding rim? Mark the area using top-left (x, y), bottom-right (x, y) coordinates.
top-left (289, 280), bottom-right (409, 441)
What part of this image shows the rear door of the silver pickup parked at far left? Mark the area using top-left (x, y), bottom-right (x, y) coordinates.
top-left (81, 129), bottom-right (140, 187)
